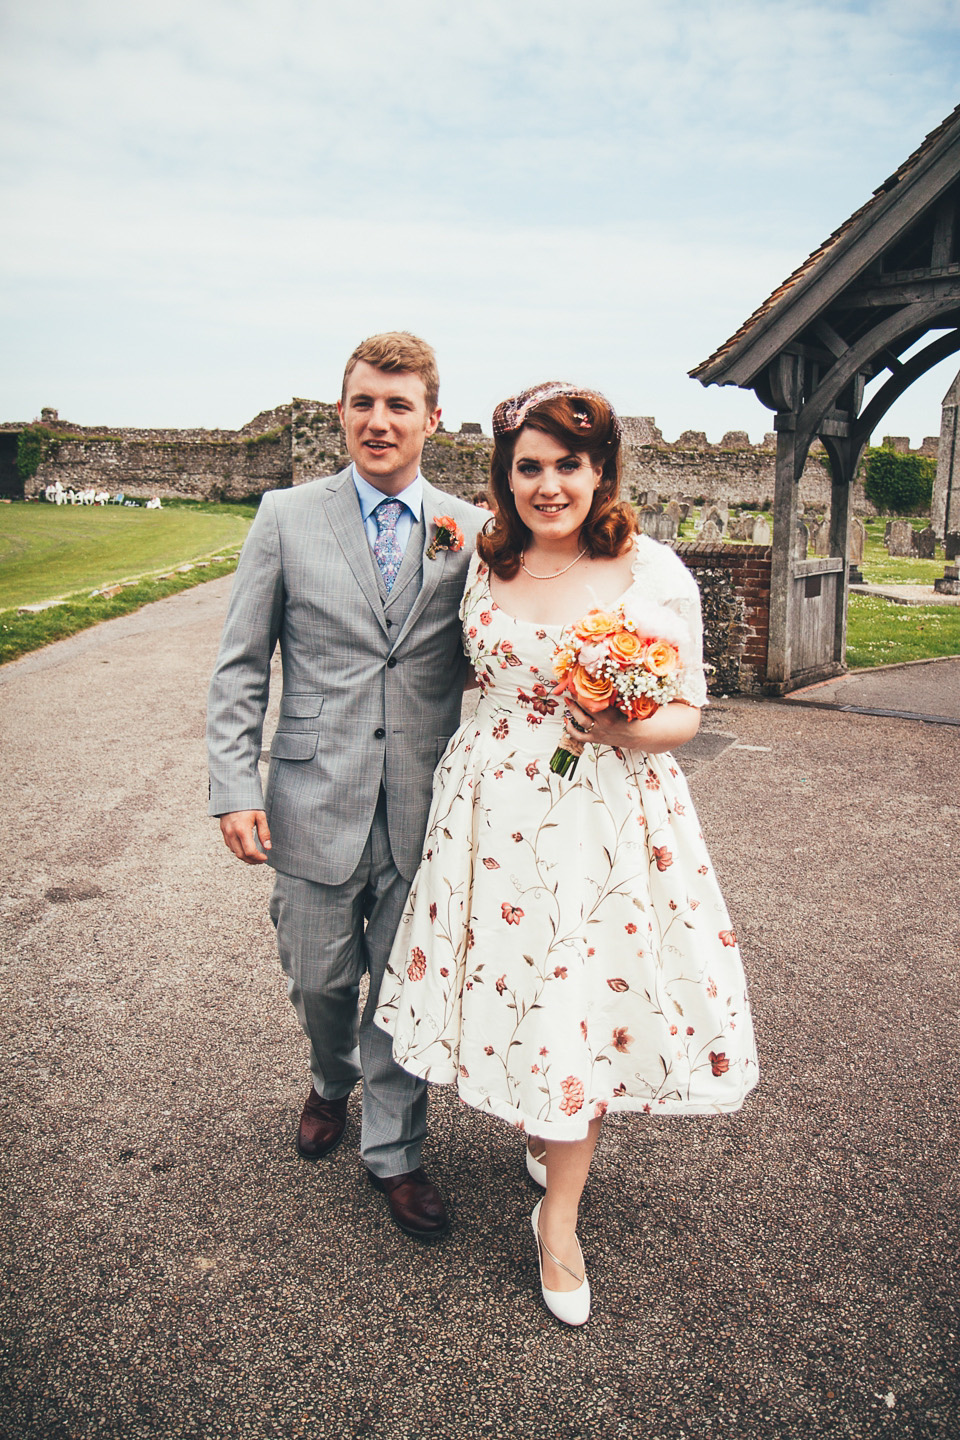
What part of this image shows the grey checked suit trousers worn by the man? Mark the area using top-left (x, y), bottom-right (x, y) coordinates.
top-left (271, 792), bottom-right (426, 1176)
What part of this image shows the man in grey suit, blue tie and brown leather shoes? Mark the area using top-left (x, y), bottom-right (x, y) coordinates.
top-left (207, 333), bottom-right (486, 1240)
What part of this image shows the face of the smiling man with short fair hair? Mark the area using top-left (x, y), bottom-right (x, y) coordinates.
top-left (337, 360), bottom-right (440, 495)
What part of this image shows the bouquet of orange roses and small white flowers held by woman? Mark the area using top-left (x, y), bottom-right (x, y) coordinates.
top-left (550, 599), bottom-right (688, 776)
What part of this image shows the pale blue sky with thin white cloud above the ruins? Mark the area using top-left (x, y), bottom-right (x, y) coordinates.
top-left (0, 0), bottom-right (960, 445)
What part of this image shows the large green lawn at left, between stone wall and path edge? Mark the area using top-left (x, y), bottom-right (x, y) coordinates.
top-left (0, 503), bottom-right (255, 611)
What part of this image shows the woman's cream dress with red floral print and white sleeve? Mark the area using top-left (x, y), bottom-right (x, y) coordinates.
top-left (377, 536), bottom-right (757, 1140)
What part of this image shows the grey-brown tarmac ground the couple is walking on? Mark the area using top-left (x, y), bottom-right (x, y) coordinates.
top-left (0, 580), bottom-right (960, 1440)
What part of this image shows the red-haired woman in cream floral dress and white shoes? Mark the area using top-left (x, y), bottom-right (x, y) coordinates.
top-left (377, 383), bottom-right (757, 1325)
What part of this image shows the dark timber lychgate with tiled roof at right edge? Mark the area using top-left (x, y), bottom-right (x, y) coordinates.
top-left (691, 107), bottom-right (960, 693)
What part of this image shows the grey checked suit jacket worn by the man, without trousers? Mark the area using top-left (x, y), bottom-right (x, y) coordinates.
top-left (207, 468), bottom-right (488, 884)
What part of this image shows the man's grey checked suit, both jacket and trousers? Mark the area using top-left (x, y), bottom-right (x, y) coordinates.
top-left (207, 468), bottom-right (488, 1175)
